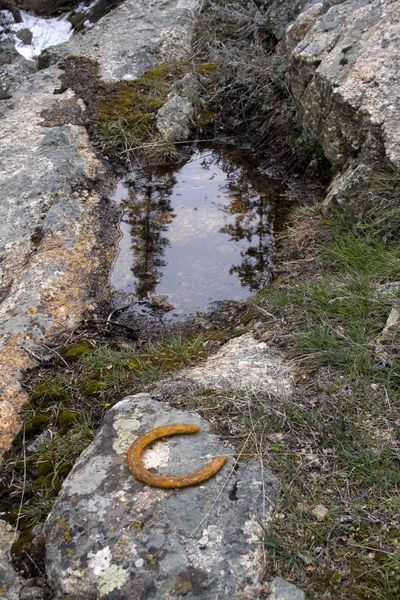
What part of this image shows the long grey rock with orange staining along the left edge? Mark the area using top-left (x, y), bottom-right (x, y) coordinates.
top-left (0, 67), bottom-right (106, 455)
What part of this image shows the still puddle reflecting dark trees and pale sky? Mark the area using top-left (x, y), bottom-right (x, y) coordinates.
top-left (110, 149), bottom-right (284, 318)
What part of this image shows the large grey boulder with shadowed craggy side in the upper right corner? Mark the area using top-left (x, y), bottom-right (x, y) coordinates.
top-left (286, 0), bottom-right (400, 168)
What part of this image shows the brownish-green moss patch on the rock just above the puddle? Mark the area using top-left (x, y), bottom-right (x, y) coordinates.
top-left (62, 55), bottom-right (219, 164)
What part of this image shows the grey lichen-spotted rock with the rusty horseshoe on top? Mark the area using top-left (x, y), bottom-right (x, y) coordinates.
top-left (45, 394), bottom-right (276, 600)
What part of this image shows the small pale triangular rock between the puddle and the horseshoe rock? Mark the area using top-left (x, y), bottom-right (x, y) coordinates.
top-left (183, 333), bottom-right (294, 396)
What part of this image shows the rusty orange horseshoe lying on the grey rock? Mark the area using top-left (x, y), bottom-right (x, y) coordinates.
top-left (126, 423), bottom-right (226, 489)
